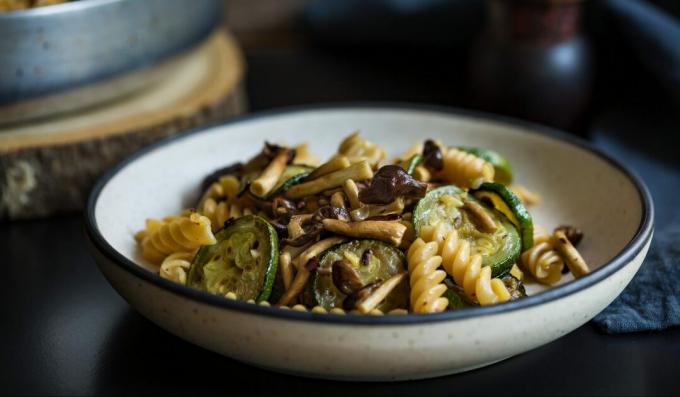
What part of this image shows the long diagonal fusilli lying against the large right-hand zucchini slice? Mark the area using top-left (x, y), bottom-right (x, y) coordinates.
top-left (421, 223), bottom-right (510, 305)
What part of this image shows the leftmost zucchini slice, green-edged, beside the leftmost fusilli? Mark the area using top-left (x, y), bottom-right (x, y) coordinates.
top-left (187, 215), bottom-right (279, 302)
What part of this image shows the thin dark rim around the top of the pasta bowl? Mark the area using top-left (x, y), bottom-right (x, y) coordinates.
top-left (85, 102), bottom-right (654, 325)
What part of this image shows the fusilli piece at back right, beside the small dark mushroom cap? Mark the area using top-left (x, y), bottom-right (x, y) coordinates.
top-left (437, 148), bottom-right (494, 189)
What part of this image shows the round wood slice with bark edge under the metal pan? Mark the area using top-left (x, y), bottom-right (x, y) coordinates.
top-left (0, 30), bottom-right (246, 219)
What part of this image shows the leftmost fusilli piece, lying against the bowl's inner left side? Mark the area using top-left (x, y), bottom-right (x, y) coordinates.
top-left (141, 213), bottom-right (217, 264)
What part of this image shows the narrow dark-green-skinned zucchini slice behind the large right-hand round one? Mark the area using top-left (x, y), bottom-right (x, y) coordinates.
top-left (472, 182), bottom-right (534, 251)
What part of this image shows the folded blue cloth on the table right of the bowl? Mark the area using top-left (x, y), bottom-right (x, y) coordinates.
top-left (593, 226), bottom-right (680, 334)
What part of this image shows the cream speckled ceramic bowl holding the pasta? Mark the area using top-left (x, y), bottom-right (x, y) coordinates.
top-left (86, 105), bottom-right (653, 380)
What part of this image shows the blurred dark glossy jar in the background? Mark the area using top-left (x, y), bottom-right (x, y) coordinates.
top-left (468, 0), bottom-right (593, 135)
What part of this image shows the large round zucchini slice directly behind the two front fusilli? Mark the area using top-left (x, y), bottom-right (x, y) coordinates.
top-left (413, 185), bottom-right (522, 277)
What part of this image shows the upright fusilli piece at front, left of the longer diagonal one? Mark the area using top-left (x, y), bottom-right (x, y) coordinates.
top-left (406, 238), bottom-right (449, 313)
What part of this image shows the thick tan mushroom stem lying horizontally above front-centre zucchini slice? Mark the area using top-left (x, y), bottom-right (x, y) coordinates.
top-left (322, 219), bottom-right (406, 247)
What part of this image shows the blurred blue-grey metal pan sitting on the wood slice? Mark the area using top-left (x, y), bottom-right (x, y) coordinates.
top-left (0, 0), bottom-right (223, 124)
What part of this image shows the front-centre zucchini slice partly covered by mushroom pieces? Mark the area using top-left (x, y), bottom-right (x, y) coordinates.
top-left (307, 240), bottom-right (409, 312)
